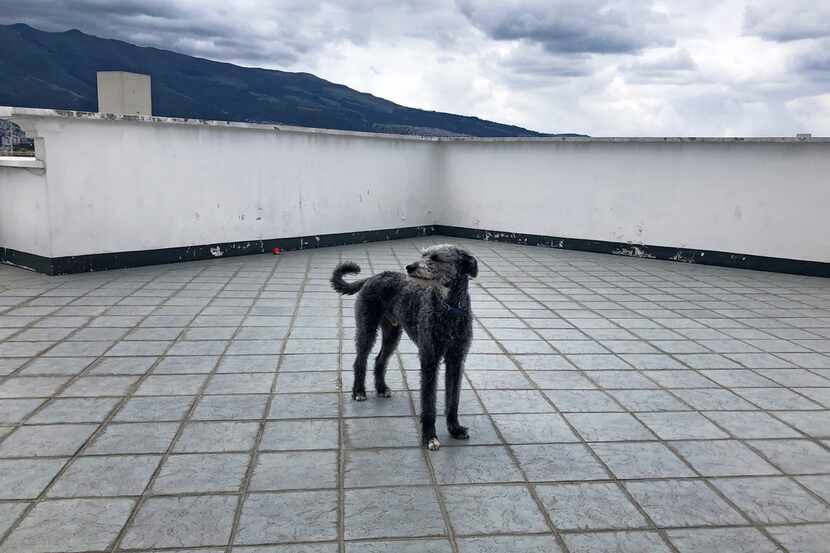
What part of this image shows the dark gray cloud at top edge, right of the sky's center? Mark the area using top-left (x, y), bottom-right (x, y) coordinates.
top-left (458, 0), bottom-right (674, 54)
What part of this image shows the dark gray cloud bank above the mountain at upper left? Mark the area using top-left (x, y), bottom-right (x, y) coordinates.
top-left (0, 0), bottom-right (352, 66)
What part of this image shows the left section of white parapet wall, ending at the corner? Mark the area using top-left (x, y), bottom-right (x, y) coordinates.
top-left (0, 109), bottom-right (439, 264)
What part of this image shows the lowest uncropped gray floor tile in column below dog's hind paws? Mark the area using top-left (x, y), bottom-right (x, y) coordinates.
top-left (344, 487), bottom-right (446, 540)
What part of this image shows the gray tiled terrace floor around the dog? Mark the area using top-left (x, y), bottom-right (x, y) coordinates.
top-left (0, 237), bottom-right (830, 553)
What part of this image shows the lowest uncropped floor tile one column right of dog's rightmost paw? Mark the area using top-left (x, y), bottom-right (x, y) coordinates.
top-left (536, 482), bottom-right (647, 530)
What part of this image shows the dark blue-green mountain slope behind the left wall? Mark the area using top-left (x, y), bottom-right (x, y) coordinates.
top-left (0, 24), bottom-right (584, 137)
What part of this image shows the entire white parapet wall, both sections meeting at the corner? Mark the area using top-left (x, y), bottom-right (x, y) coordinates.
top-left (0, 107), bottom-right (830, 275)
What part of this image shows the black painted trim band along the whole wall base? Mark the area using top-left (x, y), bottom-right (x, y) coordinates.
top-left (0, 225), bottom-right (830, 277)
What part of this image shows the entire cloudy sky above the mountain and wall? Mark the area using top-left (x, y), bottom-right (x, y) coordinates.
top-left (0, 0), bottom-right (830, 136)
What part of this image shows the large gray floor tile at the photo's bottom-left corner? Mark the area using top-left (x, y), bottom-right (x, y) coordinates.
top-left (0, 499), bottom-right (135, 553)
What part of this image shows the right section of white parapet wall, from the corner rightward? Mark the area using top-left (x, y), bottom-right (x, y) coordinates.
top-left (439, 139), bottom-right (830, 262)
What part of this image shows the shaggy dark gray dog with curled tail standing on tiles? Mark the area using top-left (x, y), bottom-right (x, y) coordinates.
top-left (331, 244), bottom-right (478, 451)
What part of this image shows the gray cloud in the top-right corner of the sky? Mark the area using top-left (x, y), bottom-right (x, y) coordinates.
top-left (744, 0), bottom-right (830, 42)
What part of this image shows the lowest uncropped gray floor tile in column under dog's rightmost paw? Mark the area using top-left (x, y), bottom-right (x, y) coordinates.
top-left (441, 486), bottom-right (548, 536)
